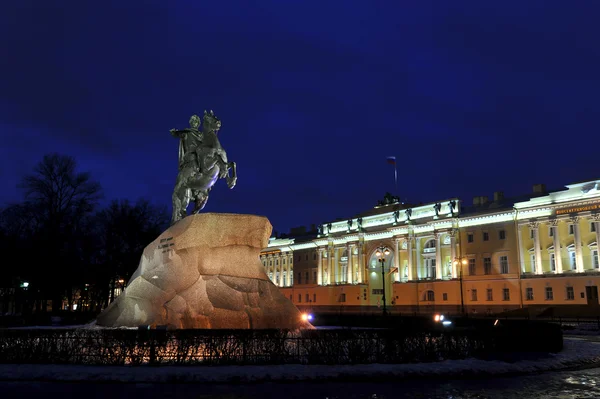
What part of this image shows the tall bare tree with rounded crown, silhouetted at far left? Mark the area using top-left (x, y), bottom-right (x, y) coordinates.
top-left (19, 154), bottom-right (101, 311)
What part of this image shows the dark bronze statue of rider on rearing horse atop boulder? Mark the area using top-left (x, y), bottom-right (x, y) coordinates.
top-left (170, 110), bottom-right (237, 225)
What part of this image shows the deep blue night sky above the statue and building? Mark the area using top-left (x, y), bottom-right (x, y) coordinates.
top-left (0, 0), bottom-right (600, 231)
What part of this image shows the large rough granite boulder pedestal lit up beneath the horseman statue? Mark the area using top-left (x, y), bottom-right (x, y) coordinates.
top-left (97, 213), bottom-right (313, 329)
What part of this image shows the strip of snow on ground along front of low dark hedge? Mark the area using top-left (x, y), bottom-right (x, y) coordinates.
top-left (0, 338), bottom-right (600, 383)
